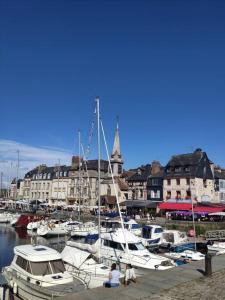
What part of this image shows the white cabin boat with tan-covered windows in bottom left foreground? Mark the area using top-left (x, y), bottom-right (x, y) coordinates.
top-left (3, 245), bottom-right (86, 300)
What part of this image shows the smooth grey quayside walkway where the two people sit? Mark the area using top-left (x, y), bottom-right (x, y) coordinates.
top-left (58, 255), bottom-right (225, 300)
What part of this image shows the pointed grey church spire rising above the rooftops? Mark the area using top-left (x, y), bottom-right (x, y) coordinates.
top-left (110, 117), bottom-right (123, 176)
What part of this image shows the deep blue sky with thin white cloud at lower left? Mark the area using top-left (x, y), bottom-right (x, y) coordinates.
top-left (0, 0), bottom-right (225, 182)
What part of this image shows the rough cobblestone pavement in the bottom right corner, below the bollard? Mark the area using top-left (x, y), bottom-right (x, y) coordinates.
top-left (147, 270), bottom-right (225, 300)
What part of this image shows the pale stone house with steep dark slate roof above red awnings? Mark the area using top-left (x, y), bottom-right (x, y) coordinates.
top-left (163, 149), bottom-right (215, 202)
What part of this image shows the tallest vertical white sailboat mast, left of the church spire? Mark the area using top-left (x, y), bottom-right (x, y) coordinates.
top-left (96, 97), bottom-right (101, 247)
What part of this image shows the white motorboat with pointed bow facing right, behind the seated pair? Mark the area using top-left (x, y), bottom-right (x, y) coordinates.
top-left (100, 228), bottom-right (174, 275)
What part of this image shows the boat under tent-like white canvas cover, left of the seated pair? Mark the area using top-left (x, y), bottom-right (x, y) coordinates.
top-left (61, 241), bottom-right (110, 288)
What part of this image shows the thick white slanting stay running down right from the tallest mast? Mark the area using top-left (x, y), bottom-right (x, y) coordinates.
top-left (100, 120), bottom-right (131, 263)
